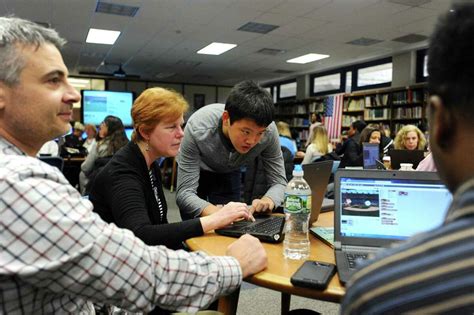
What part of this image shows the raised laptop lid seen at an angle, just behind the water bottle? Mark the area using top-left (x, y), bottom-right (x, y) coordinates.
top-left (303, 161), bottom-right (334, 226)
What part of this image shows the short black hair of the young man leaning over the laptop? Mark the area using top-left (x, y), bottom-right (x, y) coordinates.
top-left (225, 80), bottom-right (275, 127)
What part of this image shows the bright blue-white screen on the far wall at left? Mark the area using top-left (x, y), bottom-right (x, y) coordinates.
top-left (81, 90), bottom-right (133, 127)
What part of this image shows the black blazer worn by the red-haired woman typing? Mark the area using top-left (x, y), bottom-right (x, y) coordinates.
top-left (89, 142), bottom-right (203, 249)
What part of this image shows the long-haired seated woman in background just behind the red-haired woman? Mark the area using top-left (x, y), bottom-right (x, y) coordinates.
top-left (79, 115), bottom-right (128, 195)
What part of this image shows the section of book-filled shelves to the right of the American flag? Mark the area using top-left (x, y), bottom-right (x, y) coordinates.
top-left (342, 84), bottom-right (428, 136)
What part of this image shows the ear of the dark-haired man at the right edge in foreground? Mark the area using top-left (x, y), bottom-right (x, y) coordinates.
top-left (430, 96), bottom-right (457, 150)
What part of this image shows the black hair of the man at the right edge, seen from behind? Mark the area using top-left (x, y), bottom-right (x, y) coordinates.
top-left (428, 3), bottom-right (474, 121)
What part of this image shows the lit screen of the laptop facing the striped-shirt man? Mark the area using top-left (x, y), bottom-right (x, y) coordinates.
top-left (338, 177), bottom-right (452, 240)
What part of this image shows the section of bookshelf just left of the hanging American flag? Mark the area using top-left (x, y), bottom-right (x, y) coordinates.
top-left (275, 97), bottom-right (325, 149)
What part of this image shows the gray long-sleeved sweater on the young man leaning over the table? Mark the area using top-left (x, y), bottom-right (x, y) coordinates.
top-left (176, 104), bottom-right (287, 220)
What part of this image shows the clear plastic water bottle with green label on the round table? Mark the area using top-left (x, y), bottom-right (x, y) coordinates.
top-left (283, 164), bottom-right (311, 259)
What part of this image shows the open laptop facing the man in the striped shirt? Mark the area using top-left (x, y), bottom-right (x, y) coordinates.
top-left (334, 170), bottom-right (452, 283)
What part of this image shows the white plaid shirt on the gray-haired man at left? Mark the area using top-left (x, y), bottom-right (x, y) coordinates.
top-left (0, 138), bottom-right (242, 314)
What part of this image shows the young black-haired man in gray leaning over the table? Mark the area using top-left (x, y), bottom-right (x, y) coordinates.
top-left (176, 81), bottom-right (286, 220)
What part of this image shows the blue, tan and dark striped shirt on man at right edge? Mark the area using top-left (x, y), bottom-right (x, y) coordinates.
top-left (341, 178), bottom-right (474, 314)
